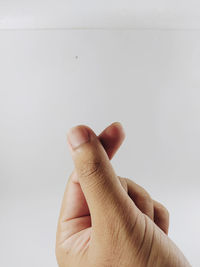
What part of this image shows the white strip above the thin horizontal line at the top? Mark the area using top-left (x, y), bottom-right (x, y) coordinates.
top-left (0, 0), bottom-right (200, 29)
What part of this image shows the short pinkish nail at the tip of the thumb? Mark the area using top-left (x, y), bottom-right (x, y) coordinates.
top-left (67, 126), bottom-right (89, 149)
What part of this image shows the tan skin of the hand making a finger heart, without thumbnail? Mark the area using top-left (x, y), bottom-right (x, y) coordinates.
top-left (56, 122), bottom-right (191, 267)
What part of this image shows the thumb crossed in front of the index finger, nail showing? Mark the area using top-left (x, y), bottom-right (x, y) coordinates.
top-left (67, 125), bottom-right (127, 226)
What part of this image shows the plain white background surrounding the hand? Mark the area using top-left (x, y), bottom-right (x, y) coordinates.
top-left (0, 0), bottom-right (200, 267)
